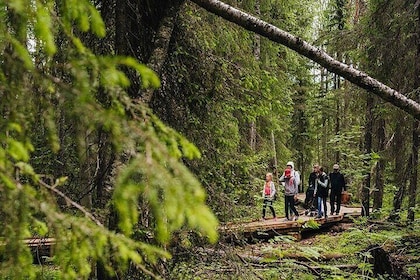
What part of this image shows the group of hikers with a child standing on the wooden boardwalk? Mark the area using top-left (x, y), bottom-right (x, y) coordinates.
top-left (262, 161), bottom-right (346, 221)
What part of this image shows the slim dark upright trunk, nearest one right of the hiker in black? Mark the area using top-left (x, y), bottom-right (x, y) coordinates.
top-left (361, 95), bottom-right (374, 216)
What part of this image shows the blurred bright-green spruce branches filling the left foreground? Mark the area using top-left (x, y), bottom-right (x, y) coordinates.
top-left (0, 1), bottom-right (217, 279)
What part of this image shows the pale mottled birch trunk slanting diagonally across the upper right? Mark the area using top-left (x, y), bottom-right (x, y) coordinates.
top-left (191, 0), bottom-right (420, 120)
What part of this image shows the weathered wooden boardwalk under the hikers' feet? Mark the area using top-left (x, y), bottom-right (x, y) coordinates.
top-left (220, 193), bottom-right (361, 239)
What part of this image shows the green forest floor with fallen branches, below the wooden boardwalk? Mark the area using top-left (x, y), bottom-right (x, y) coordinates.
top-left (174, 194), bottom-right (420, 280)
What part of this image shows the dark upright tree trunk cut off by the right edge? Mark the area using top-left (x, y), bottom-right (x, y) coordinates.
top-left (407, 0), bottom-right (420, 222)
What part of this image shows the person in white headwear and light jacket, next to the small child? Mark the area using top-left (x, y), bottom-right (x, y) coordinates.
top-left (279, 161), bottom-right (300, 221)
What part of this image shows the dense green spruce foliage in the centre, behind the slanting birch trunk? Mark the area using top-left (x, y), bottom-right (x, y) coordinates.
top-left (152, 1), bottom-right (318, 223)
